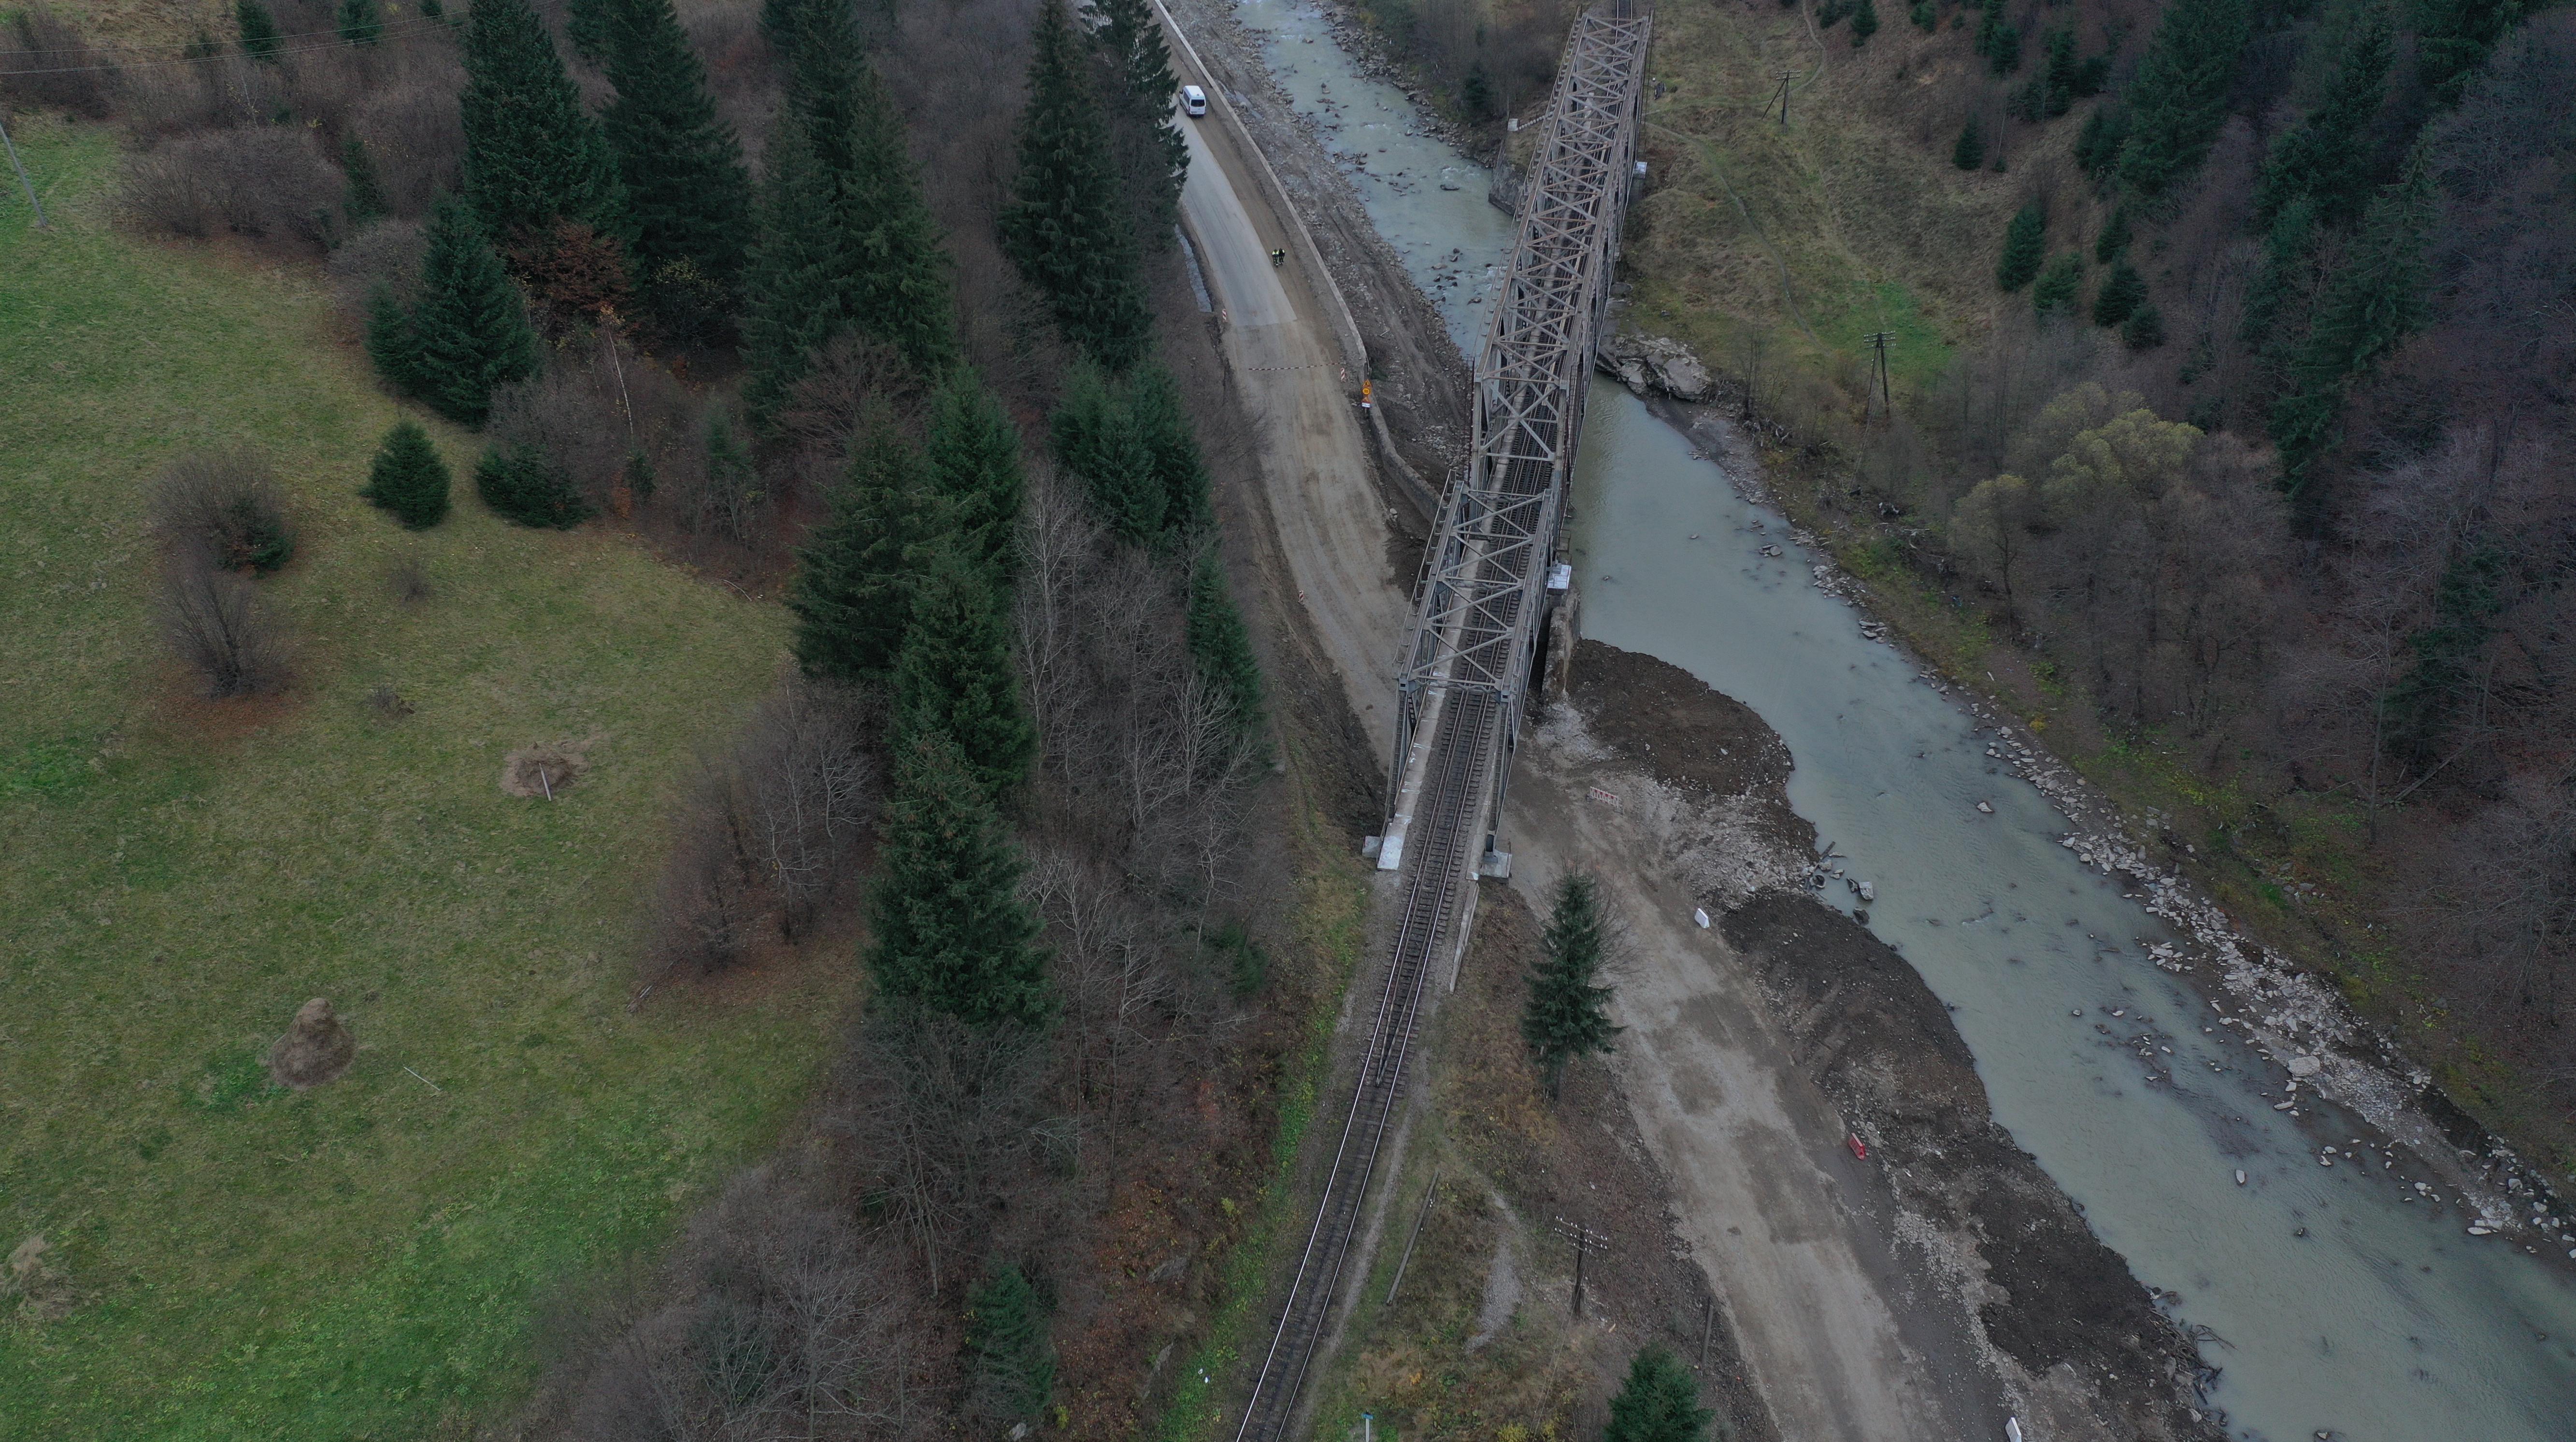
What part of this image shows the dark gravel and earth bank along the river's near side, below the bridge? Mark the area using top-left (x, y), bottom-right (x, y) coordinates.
top-left (1572, 641), bottom-right (2220, 1440)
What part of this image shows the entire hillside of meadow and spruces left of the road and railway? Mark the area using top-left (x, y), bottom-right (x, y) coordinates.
top-left (0, 0), bottom-right (1368, 1440)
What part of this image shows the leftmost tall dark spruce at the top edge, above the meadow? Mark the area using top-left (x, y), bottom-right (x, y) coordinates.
top-left (456, 0), bottom-right (623, 244)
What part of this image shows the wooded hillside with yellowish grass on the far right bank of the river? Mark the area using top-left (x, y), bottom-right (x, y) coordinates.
top-left (1368, 0), bottom-right (2576, 1143)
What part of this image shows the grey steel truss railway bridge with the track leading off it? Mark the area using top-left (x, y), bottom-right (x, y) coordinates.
top-left (1236, 0), bottom-right (1651, 1442)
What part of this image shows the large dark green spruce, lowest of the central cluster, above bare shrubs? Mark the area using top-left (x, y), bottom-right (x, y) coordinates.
top-left (868, 726), bottom-right (1054, 1028)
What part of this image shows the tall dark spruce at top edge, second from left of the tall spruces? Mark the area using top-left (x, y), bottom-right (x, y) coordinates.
top-left (592, 0), bottom-right (752, 311)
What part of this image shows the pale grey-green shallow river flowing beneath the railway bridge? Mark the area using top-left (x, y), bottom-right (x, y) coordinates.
top-left (1236, 0), bottom-right (2576, 1442)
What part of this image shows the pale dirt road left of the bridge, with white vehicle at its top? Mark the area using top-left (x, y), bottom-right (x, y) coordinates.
top-left (1174, 54), bottom-right (1412, 757)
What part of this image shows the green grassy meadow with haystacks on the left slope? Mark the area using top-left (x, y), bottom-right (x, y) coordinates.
top-left (0, 118), bottom-right (855, 1442)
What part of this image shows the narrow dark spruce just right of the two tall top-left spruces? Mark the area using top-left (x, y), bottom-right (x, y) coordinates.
top-left (742, 106), bottom-right (850, 430)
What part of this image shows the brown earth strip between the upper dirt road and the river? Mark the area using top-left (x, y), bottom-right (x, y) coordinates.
top-left (1170, 0), bottom-right (1474, 510)
